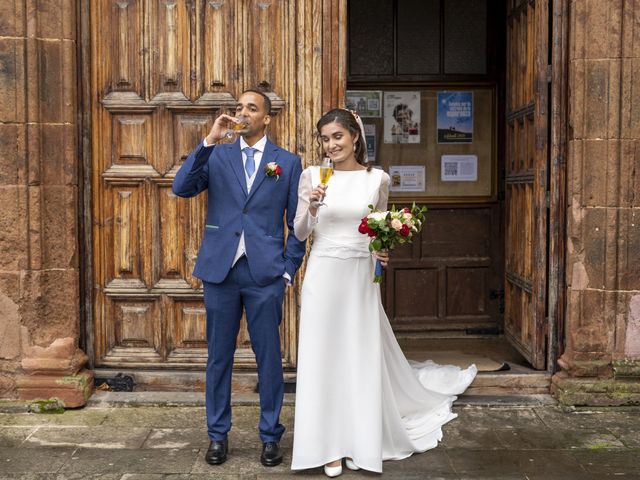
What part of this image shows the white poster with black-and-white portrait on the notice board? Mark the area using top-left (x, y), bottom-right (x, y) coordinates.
top-left (384, 92), bottom-right (420, 143)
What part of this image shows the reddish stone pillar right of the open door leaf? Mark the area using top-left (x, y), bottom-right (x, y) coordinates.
top-left (554, 0), bottom-right (640, 404)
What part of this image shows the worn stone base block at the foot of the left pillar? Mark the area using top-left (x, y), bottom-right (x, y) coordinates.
top-left (16, 370), bottom-right (93, 408)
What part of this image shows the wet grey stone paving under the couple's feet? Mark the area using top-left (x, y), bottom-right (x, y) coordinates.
top-left (0, 398), bottom-right (640, 480)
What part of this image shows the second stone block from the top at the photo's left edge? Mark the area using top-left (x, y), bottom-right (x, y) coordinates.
top-left (0, 38), bottom-right (26, 122)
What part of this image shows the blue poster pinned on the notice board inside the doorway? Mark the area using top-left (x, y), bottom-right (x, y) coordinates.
top-left (438, 92), bottom-right (473, 143)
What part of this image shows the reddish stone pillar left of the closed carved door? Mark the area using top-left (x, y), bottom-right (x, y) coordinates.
top-left (0, 0), bottom-right (91, 406)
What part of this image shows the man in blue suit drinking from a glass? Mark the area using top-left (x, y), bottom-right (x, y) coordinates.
top-left (173, 90), bottom-right (305, 467)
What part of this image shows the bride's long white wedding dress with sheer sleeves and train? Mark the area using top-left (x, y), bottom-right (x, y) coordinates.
top-left (291, 167), bottom-right (477, 472)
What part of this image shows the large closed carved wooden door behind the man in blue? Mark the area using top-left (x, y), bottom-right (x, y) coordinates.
top-left (89, 0), bottom-right (322, 369)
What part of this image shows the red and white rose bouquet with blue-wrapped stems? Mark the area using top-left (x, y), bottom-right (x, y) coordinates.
top-left (358, 202), bottom-right (427, 283)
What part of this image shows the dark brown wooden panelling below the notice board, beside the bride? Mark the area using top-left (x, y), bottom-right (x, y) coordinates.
top-left (384, 205), bottom-right (502, 334)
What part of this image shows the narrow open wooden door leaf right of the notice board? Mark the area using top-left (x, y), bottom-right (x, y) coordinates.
top-left (504, 0), bottom-right (549, 369)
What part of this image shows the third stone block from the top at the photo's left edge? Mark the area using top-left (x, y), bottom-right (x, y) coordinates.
top-left (0, 124), bottom-right (26, 185)
